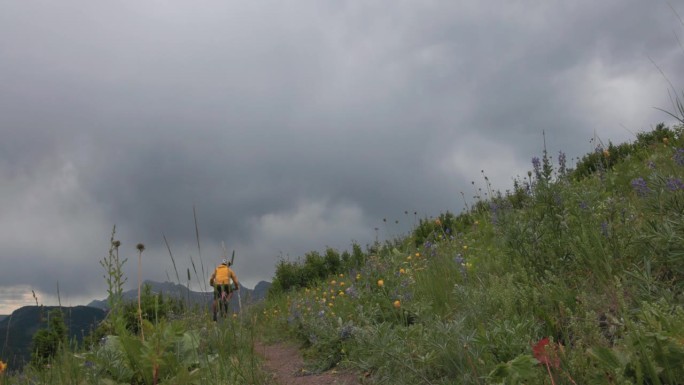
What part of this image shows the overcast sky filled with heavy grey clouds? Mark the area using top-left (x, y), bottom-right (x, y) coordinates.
top-left (0, 0), bottom-right (684, 314)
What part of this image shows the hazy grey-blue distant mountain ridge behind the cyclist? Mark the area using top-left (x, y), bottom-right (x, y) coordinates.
top-left (88, 280), bottom-right (271, 311)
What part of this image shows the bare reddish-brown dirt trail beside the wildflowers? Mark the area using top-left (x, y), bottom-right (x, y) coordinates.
top-left (254, 342), bottom-right (361, 385)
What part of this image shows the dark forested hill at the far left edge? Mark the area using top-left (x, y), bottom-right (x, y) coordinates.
top-left (0, 306), bottom-right (107, 369)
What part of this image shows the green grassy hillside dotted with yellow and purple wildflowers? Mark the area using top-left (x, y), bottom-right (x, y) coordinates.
top-left (258, 125), bottom-right (684, 384)
